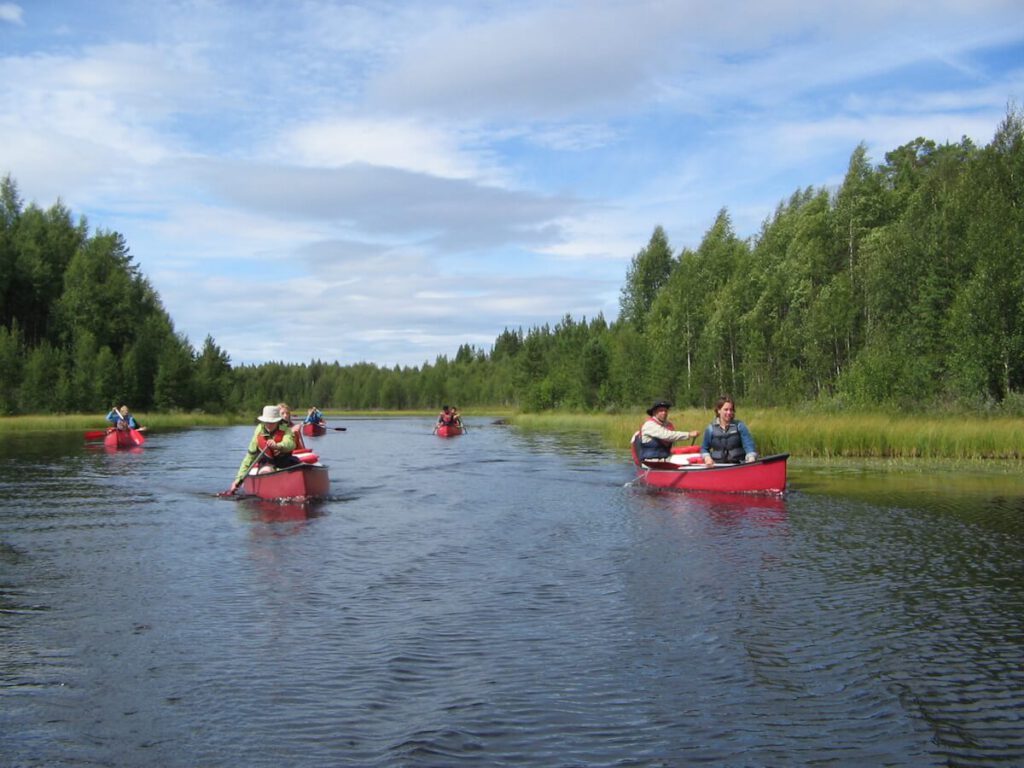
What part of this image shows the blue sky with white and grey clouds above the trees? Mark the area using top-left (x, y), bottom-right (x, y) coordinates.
top-left (0, 0), bottom-right (1024, 366)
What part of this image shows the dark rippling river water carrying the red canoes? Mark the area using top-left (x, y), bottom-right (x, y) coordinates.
top-left (0, 418), bottom-right (1024, 768)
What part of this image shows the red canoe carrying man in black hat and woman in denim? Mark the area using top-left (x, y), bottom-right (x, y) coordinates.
top-left (630, 432), bottom-right (790, 494)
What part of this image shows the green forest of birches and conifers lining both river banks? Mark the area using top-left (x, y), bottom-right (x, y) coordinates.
top-left (0, 108), bottom-right (1024, 414)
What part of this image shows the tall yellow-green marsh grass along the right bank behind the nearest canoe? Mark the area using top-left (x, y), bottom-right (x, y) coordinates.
top-left (510, 409), bottom-right (1024, 460)
